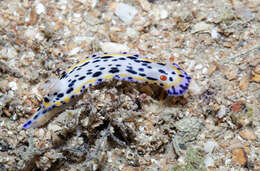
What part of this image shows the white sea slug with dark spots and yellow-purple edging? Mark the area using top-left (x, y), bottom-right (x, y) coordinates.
top-left (23, 53), bottom-right (191, 128)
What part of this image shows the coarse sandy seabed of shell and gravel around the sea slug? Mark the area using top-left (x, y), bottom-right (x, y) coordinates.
top-left (0, 0), bottom-right (260, 171)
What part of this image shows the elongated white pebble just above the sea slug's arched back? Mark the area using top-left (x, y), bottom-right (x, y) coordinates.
top-left (100, 42), bottom-right (129, 53)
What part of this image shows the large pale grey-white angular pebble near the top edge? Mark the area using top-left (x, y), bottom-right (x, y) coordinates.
top-left (115, 3), bottom-right (137, 24)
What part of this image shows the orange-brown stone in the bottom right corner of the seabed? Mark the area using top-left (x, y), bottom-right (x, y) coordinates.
top-left (232, 148), bottom-right (247, 166)
